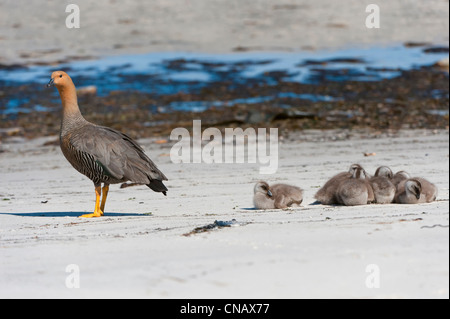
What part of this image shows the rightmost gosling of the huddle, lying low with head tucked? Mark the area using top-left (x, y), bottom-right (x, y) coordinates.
top-left (394, 177), bottom-right (438, 204)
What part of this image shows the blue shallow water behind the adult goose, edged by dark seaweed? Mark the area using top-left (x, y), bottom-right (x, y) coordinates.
top-left (0, 45), bottom-right (448, 114)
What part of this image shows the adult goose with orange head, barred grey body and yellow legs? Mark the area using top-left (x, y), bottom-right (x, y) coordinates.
top-left (49, 71), bottom-right (167, 217)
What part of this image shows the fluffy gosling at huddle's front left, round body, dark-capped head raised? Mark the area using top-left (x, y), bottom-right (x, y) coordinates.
top-left (336, 168), bottom-right (374, 206)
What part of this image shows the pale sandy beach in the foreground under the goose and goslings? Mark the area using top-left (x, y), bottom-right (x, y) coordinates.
top-left (0, 130), bottom-right (449, 298)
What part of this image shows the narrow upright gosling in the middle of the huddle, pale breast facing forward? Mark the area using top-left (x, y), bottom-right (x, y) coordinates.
top-left (370, 166), bottom-right (396, 204)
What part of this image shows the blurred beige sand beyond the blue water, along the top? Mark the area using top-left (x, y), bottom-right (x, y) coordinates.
top-left (0, 0), bottom-right (449, 64)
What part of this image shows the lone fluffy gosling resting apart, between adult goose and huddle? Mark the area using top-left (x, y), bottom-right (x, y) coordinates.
top-left (253, 181), bottom-right (303, 209)
